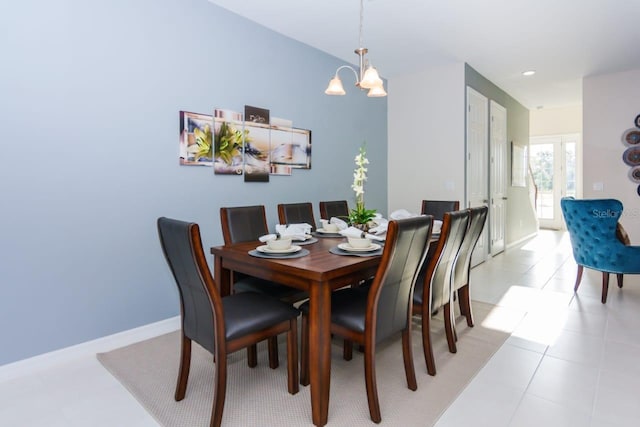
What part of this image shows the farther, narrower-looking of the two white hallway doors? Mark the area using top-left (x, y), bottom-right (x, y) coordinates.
top-left (489, 100), bottom-right (507, 255)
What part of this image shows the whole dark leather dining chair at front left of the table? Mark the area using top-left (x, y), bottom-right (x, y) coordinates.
top-left (157, 217), bottom-right (300, 427)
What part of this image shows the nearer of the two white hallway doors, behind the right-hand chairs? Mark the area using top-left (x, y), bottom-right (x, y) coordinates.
top-left (466, 86), bottom-right (489, 265)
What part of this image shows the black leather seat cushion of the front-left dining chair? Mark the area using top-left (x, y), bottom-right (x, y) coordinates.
top-left (222, 292), bottom-right (300, 340)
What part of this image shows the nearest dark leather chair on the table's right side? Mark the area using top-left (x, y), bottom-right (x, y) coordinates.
top-left (300, 216), bottom-right (433, 423)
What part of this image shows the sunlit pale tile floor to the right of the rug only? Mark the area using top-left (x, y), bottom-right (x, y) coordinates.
top-left (436, 231), bottom-right (640, 427)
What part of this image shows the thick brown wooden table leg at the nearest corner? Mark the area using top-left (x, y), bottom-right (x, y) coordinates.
top-left (309, 283), bottom-right (331, 427)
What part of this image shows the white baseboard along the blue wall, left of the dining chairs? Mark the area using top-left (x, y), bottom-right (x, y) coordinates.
top-left (0, 316), bottom-right (180, 381)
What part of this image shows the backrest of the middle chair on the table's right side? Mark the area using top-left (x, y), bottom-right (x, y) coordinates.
top-left (422, 210), bottom-right (469, 310)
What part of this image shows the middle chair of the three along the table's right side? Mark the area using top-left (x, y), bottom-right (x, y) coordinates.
top-left (413, 210), bottom-right (469, 375)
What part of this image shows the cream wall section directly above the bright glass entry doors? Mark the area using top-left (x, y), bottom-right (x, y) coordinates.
top-left (529, 105), bottom-right (582, 136)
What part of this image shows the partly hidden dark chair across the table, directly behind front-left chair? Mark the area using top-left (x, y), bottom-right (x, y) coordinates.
top-left (220, 205), bottom-right (308, 369)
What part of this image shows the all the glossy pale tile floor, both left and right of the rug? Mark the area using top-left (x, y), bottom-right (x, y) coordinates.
top-left (0, 231), bottom-right (640, 427)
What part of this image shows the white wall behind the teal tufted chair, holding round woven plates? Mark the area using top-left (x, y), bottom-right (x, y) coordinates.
top-left (582, 69), bottom-right (640, 245)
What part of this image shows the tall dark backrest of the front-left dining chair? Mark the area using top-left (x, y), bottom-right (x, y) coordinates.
top-left (158, 217), bottom-right (224, 353)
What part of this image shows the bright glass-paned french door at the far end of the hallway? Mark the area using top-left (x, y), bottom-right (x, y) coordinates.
top-left (529, 134), bottom-right (580, 230)
